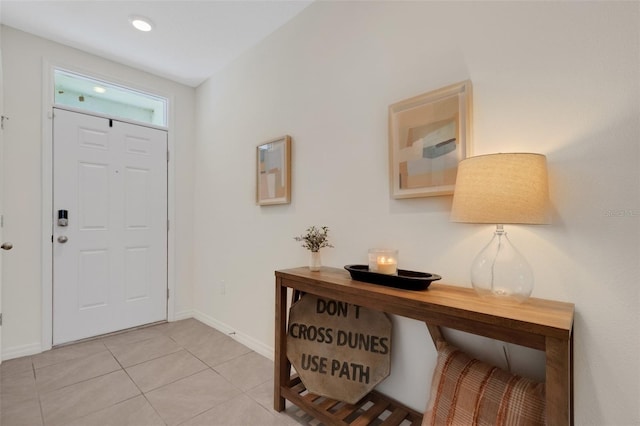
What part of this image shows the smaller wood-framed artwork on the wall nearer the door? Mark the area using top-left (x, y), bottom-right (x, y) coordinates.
top-left (256, 135), bottom-right (291, 206)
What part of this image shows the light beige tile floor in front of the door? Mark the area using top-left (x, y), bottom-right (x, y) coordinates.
top-left (0, 319), bottom-right (319, 426)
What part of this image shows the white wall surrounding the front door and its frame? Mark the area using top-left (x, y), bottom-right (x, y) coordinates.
top-left (1, 26), bottom-right (195, 359)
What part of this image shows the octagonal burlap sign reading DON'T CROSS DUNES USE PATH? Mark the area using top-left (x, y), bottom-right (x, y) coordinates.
top-left (287, 294), bottom-right (391, 404)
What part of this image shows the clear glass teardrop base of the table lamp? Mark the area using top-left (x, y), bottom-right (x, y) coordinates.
top-left (471, 225), bottom-right (533, 303)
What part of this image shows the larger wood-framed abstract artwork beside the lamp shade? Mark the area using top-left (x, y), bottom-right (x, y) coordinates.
top-left (389, 80), bottom-right (472, 198)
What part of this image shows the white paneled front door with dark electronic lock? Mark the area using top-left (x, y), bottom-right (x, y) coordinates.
top-left (52, 108), bottom-right (167, 345)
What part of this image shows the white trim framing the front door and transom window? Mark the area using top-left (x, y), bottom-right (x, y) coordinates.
top-left (40, 58), bottom-right (176, 351)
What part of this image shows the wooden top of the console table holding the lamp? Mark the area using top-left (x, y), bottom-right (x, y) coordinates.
top-left (275, 266), bottom-right (574, 339)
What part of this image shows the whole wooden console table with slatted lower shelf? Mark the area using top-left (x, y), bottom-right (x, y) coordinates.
top-left (274, 267), bottom-right (574, 426)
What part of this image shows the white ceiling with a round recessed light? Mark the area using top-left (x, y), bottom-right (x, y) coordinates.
top-left (0, 0), bottom-right (312, 87)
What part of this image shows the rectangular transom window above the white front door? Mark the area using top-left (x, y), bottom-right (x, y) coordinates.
top-left (54, 69), bottom-right (168, 127)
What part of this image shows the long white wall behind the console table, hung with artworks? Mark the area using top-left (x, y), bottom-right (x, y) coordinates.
top-left (194, 2), bottom-right (640, 425)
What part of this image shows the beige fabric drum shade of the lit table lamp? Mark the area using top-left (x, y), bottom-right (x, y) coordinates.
top-left (451, 153), bottom-right (549, 224)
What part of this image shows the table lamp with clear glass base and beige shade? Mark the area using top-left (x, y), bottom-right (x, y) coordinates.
top-left (451, 153), bottom-right (549, 302)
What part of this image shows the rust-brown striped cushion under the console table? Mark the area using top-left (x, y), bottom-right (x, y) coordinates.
top-left (422, 342), bottom-right (545, 426)
